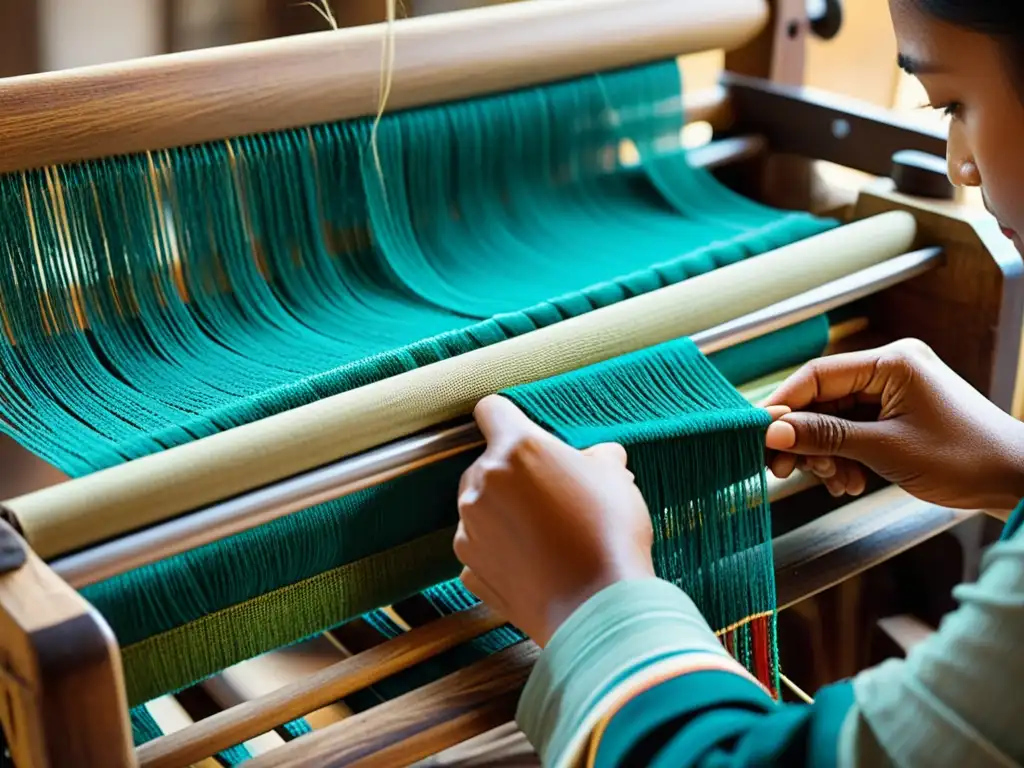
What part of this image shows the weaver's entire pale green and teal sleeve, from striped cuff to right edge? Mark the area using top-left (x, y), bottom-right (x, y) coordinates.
top-left (518, 524), bottom-right (1024, 768)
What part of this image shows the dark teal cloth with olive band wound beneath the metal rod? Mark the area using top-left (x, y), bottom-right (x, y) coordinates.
top-left (83, 317), bottom-right (828, 703)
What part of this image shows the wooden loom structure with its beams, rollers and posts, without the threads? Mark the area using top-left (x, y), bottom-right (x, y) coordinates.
top-left (0, 0), bottom-right (1024, 768)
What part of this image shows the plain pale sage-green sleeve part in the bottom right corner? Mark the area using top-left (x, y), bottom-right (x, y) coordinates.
top-left (849, 512), bottom-right (1024, 768)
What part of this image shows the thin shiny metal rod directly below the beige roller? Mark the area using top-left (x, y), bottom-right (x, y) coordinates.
top-left (51, 248), bottom-right (943, 589)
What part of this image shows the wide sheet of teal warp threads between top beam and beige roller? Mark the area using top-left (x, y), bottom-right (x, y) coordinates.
top-left (0, 61), bottom-right (836, 475)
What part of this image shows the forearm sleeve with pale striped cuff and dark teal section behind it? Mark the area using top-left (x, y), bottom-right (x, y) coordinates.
top-left (517, 580), bottom-right (853, 768)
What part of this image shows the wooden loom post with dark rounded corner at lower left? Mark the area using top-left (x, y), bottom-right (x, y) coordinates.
top-left (0, 518), bottom-right (135, 768)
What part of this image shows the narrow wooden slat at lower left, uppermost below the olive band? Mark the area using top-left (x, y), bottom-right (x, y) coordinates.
top-left (137, 605), bottom-right (504, 768)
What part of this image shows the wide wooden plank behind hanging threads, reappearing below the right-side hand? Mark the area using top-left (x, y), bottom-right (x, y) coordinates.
top-left (239, 486), bottom-right (978, 768)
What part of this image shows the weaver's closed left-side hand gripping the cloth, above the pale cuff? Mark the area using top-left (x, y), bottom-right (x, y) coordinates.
top-left (455, 395), bottom-right (654, 646)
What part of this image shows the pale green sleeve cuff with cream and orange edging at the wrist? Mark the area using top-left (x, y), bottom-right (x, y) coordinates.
top-left (516, 579), bottom-right (767, 768)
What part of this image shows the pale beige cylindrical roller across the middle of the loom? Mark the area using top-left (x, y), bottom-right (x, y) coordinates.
top-left (4, 212), bottom-right (916, 559)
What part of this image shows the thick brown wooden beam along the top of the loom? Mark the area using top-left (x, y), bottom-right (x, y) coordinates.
top-left (0, 0), bottom-right (767, 172)
